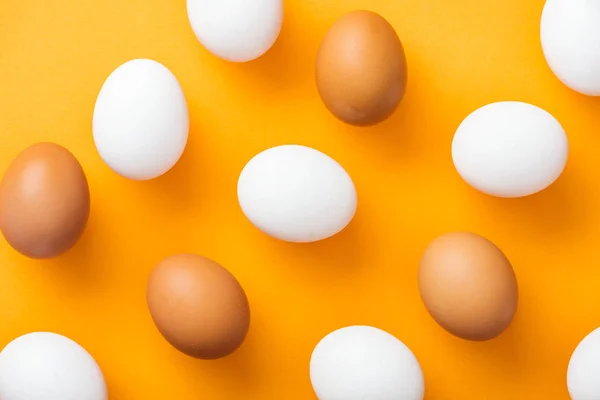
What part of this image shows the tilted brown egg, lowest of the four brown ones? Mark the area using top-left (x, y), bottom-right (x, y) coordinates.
top-left (146, 254), bottom-right (250, 360)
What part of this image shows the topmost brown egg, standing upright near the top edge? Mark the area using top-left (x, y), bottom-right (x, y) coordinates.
top-left (316, 11), bottom-right (406, 126)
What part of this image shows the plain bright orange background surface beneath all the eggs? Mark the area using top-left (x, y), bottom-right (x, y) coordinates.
top-left (0, 0), bottom-right (600, 400)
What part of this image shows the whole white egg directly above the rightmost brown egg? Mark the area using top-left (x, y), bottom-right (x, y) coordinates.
top-left (452, 101), bottom-right (569, 197)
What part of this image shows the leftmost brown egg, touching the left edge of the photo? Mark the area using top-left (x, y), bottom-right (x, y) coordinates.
top-left (0, 143), bottom-right (90, 258)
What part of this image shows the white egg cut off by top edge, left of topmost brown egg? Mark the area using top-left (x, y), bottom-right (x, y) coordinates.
top-left (187, 0), bottom-right (283, 62)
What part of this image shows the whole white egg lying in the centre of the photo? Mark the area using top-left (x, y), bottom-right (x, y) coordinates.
top-left (238, 145), bottom-right (357, 242)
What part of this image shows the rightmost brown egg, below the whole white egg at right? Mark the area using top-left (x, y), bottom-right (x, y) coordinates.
top-left (419, 232), bottom-right (519, 341)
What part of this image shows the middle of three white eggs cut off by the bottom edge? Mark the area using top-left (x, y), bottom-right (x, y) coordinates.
top-left (310, 326), bottom-right (425, 400)
